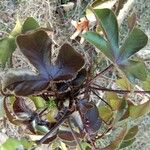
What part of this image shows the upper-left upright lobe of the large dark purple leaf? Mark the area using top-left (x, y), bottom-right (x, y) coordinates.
top-left (17, 30), bottom-right (52, 75)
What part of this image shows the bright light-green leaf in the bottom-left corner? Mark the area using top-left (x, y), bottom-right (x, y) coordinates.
top-left (0, 138), bottom-right (32, 150)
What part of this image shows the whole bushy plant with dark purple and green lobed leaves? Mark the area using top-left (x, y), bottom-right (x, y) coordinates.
top-left (0, 5), bottom-right (150, 150)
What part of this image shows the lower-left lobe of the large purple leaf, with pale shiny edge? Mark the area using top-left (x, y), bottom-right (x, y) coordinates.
top-left (2, 70), bottom-right (49, 96)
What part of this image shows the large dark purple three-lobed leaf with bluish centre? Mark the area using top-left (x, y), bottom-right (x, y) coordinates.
top-left (3, 30), bottom-right (85, 96)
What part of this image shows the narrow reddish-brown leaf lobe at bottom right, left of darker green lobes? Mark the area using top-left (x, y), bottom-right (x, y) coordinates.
top-left (101, 127), bottom-right (127, 150)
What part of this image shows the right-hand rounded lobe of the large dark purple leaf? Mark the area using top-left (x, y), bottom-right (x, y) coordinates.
top-left (49, 44), bottom-right (85, 81)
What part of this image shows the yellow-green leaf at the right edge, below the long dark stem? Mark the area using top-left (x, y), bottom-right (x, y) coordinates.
top-left (129, 101), bottom-right (150, 119)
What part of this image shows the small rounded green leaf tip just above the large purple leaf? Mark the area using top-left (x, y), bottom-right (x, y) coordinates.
top-left (22, 17), bottom-right (40, 33)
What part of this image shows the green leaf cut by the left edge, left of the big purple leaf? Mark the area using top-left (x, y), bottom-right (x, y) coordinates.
top-left (0, 37), bottom-right (16, 68)
